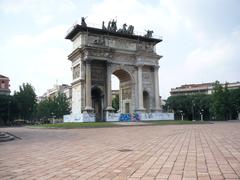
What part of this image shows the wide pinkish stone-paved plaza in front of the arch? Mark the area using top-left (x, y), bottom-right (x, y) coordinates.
top-left (0, 122), bottom-right (240, 180)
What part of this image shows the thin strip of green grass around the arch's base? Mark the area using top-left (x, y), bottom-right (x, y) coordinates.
top-left (30, 120), bottom-right (206, 129)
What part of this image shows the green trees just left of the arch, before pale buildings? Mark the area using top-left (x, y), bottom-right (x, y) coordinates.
top-left (37, 93), bottom-right (70, 119)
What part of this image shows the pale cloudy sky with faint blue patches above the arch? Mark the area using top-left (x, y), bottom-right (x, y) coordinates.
top-left (0, 0), bottom-right (240, 98)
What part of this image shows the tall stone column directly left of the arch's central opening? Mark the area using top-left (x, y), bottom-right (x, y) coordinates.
top-left (106, 62), bottom-right (114, 111)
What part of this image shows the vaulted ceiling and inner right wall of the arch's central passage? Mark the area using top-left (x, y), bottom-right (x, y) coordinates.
top-left (112, 69), bottom-right (134, 113)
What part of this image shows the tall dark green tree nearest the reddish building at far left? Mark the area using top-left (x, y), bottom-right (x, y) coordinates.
top-left (14, 83), bottom-right (37, 120)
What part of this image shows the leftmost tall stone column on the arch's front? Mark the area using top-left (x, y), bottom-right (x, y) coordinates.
top-left (84, 59), bottom-right (93, 111)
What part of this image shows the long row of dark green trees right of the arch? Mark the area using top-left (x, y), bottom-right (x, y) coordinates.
top-left (168, 81), bottom-right (240, 120)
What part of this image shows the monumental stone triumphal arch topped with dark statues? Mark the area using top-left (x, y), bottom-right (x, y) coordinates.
top-left (65, 18), bottom-right (172, 122)
